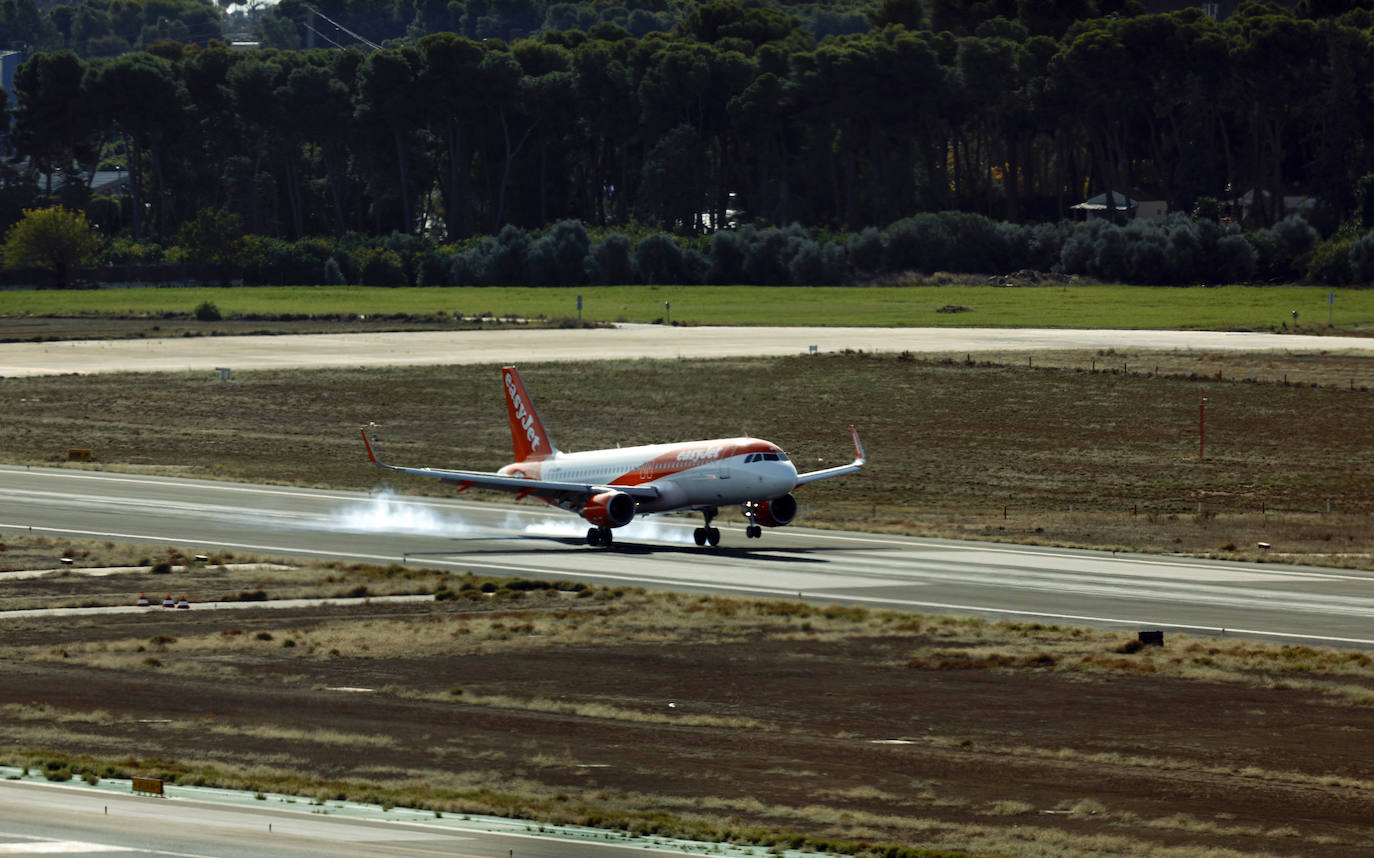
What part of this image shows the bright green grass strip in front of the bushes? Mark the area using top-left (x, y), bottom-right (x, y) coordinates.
top-left (0, 285), bottom-right (1374, 330)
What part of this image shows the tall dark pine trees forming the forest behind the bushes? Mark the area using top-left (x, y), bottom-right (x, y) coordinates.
top-left (0, 0), bottom-right (1374, 281)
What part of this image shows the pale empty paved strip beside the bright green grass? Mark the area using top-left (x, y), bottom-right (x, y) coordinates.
top-left (0, 325), bottom-right (1374, 377)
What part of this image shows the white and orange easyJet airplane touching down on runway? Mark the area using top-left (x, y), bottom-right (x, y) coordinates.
top-left (361, 366), bottom-right (867, 549)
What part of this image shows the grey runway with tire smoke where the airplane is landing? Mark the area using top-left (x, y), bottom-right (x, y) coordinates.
top-left (0, 466), bottom-right (1374, 648)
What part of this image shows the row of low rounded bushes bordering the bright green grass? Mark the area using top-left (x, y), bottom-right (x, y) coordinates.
top-left (16, 206), bottom-right (1374, 287)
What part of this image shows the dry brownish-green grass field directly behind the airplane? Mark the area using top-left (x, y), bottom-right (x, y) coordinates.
top-left (0, 352), bottom-right (1374, 567)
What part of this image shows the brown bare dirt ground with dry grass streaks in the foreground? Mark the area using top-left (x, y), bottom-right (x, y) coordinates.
top-left (0, 539), bottom-right (1374, 858)
